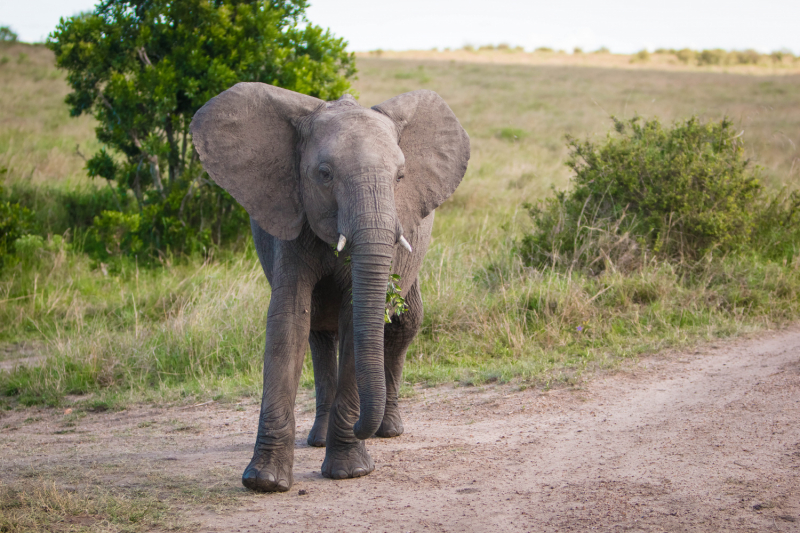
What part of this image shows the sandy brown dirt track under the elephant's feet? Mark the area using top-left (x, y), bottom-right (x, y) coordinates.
top-left (0, 326), bottom-right (800, 532)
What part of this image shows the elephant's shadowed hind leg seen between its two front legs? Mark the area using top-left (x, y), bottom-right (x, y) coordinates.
top-left (308, 331), bottom-right (336, 448)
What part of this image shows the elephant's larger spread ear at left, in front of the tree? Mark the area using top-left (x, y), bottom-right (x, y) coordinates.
top-left (191, 83), bottom-right (324, 240)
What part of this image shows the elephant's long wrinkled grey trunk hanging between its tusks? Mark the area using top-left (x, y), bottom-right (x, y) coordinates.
top-left (347, 178), bottom-right (398, 439)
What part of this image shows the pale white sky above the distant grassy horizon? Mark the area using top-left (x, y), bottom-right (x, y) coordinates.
top-left (0, 0), bottom-right (800, 54)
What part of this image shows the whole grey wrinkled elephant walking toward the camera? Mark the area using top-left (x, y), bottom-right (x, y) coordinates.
top-left (192, 83), bottom-right (469, 491)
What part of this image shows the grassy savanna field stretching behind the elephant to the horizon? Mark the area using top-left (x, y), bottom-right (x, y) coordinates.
top-left (0, 45), bottom-right (800, 409)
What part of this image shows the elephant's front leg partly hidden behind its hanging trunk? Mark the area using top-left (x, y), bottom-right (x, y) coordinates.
top-left (322, 304), bottom-right (375, 479)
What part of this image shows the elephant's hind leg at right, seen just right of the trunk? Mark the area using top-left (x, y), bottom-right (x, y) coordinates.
top-left (375, 279), bottom-right (423, 438)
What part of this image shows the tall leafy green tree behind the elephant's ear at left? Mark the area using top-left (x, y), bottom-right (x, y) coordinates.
top-left (48, 0), bottom-right (355, 253)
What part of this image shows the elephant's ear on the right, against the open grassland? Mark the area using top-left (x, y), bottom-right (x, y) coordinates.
top-left (372, 91), bottom-right (469, 230)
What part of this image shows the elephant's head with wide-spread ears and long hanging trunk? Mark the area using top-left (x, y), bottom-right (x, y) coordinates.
top-left (192, 83), bottom-right (469, 439)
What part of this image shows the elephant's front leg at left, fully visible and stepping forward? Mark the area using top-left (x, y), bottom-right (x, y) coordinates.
top-left (242, 278), bottom-right (311, 492)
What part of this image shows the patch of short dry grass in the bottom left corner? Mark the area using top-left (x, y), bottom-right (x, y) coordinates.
top-left (0, 458), bottom-right (254, 533)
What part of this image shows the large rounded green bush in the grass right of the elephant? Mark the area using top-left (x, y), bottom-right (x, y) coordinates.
top-left (521, 117), bottom-right (764, 271)
